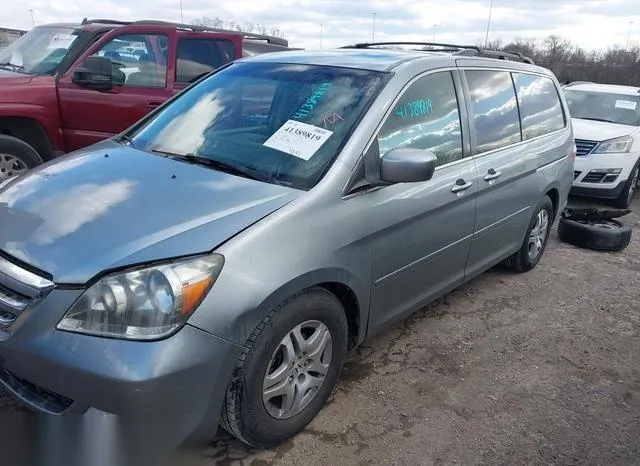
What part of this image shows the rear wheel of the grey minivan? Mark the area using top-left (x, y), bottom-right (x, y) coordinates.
top-left (504, 196), bottom-right (554, 272)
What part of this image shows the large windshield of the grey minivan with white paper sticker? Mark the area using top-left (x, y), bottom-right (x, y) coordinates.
top-left (127, 62), bottom-right (388, 190)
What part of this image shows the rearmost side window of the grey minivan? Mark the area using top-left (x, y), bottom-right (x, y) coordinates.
top-left (512, 73), bottom-right (566, 140)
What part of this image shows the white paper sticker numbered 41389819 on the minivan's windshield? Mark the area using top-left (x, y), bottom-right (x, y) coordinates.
top-left (264, 120), bottom-right (333, 160)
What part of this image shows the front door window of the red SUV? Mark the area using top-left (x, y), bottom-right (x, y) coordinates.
top-left (94, 34), bottom-right (167, 87)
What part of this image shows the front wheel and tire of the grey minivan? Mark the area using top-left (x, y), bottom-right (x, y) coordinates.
top-left (221, 288), bottom-right (348, 448)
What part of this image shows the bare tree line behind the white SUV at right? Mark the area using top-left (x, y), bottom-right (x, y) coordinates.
top-left (483, 35), bottom-right (640, 87)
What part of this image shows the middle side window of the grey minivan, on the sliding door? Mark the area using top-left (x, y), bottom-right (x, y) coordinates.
top-left (464, 70), bottom-right (522, 153)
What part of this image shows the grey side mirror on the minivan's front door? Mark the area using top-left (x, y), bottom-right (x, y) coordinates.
top-left (380, 147), bottom-right (438, 183)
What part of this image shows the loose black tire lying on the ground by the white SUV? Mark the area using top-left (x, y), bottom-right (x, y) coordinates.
top-left (558, 217), bottom-right (631, 251)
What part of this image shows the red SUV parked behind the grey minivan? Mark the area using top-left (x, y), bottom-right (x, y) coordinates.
top-left (0, 19), bottom-right (290, 182)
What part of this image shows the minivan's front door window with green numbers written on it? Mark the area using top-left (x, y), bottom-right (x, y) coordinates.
top-left (378, 71), bottom-right (462, 165)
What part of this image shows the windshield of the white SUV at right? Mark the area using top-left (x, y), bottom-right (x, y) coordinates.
top-left (564, 89), bottom-right (640, 126)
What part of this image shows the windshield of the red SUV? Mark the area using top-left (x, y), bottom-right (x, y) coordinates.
top-left (0, 26), bottom-right (81, 75)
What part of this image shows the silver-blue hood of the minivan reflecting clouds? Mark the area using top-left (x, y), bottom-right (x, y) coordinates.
top-left (0, 145), bottom-right (303, 284)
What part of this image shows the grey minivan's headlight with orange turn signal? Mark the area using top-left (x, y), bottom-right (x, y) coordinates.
top-left (57, 254), bottom-right (224, 340)
